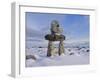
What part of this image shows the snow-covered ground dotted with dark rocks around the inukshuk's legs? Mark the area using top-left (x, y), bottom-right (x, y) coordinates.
top-left (26, 43), bottom-right (90, 67)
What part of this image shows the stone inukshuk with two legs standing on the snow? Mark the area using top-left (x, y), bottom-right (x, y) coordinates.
top-left (45, 20), bottom-right (65, 57)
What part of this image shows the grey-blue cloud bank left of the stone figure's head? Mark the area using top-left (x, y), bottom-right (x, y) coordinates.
top-left (26, 27), bottom-right (50, 42)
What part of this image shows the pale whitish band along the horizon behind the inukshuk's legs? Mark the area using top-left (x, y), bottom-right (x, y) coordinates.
top-left (26, 41), bottom-right (89, 48)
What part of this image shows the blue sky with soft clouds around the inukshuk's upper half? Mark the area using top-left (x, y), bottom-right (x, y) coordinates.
top-left (26, 12), bottom-right (89, 42)
